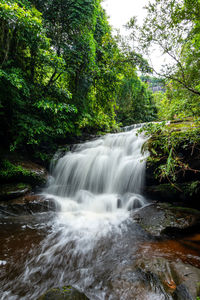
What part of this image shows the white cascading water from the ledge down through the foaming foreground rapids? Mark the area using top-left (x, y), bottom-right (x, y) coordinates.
top-left (1, 129), bottom-right (152, 300)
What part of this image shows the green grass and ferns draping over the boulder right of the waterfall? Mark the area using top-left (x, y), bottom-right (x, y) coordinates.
top-left (139, 119), bottom-right (200, 183)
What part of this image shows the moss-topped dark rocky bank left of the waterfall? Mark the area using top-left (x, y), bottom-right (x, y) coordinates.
top-left (0, 156), bottom-right (48, 207)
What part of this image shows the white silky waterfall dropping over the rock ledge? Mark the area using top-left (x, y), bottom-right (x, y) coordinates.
top-left (45, 127), bottom-right (146, 213)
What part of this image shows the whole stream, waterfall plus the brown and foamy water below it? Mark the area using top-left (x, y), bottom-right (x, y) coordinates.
top-left (0, 129), bottom-right (200, 300)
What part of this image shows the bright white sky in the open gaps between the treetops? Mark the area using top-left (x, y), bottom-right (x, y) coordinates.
top-left (102, 0), bottom-right (164, 70)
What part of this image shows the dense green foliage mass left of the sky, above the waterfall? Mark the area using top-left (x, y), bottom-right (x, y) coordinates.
top-left (0, 0), bottom-right (155, 159)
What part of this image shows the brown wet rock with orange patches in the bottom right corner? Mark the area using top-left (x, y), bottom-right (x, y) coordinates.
top-left (111, 257), bottom-right (200, 300)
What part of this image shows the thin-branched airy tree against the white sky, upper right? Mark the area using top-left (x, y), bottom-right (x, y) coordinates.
top-left (129, 0), bottom-right (200, 96)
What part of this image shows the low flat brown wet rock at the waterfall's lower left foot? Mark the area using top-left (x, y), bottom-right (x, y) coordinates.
top-left (0, 195), bottom-right (60, 216)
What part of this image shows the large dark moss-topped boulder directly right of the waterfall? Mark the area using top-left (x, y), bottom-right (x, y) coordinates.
top-left (144, 119), bottom-right (200, 209)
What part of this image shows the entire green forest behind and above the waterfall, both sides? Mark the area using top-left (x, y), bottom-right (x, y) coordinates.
top-left (0, 0), bottom-right (200, 163)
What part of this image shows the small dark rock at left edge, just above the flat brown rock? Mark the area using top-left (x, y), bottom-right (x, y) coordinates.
top-left (0, 183), bottom-right (31, 201)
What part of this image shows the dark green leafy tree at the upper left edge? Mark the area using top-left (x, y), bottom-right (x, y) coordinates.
top-left (0, 0), bottom-right (76, 155)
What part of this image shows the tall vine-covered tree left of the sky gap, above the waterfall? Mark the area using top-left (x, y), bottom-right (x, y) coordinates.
top-left (32, 0), bottom-right (121, 130)
